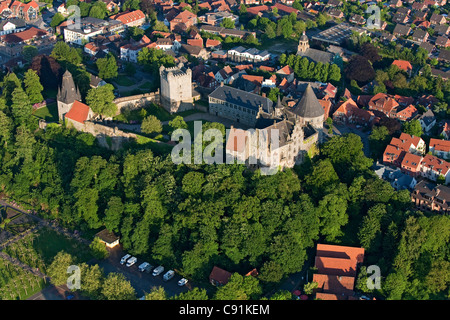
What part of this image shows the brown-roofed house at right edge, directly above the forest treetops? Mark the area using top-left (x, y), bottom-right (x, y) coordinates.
top-left (411, 180), bottom-right (450, 213)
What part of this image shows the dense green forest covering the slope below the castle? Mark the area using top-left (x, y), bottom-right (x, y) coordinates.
top-left (0, 67), bottom-right (450, 299)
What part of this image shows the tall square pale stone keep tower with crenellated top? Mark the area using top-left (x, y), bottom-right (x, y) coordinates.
top-left (159, 63), bottom-right (193, 113)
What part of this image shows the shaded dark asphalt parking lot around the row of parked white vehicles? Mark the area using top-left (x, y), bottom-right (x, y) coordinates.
top-left (95, 247), bottom-right (192, 298)
